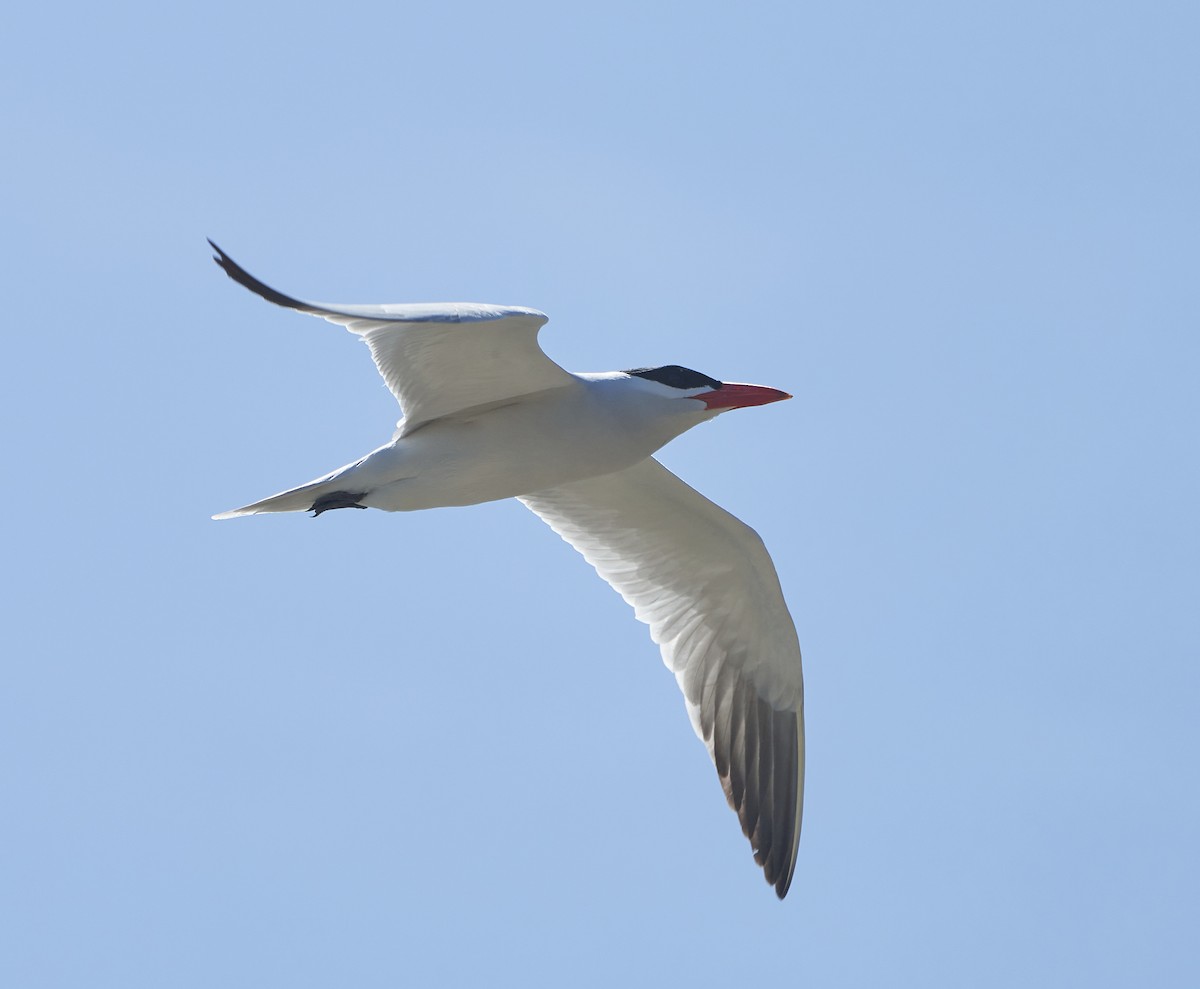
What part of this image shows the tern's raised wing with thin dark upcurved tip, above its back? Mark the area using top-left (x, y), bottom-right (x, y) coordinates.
top-left (209, 240), bottom-right (574, 433)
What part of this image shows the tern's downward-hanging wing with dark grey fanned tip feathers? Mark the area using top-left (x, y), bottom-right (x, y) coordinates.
top-left (521, 460), bottom-right (804, 899)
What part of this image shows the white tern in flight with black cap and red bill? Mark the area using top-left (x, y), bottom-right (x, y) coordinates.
top-left (209, 240), bottom-right (804, 899)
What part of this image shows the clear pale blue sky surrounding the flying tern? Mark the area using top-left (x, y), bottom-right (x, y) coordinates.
top-left (0, 0), bottom-right (1200, 989)
